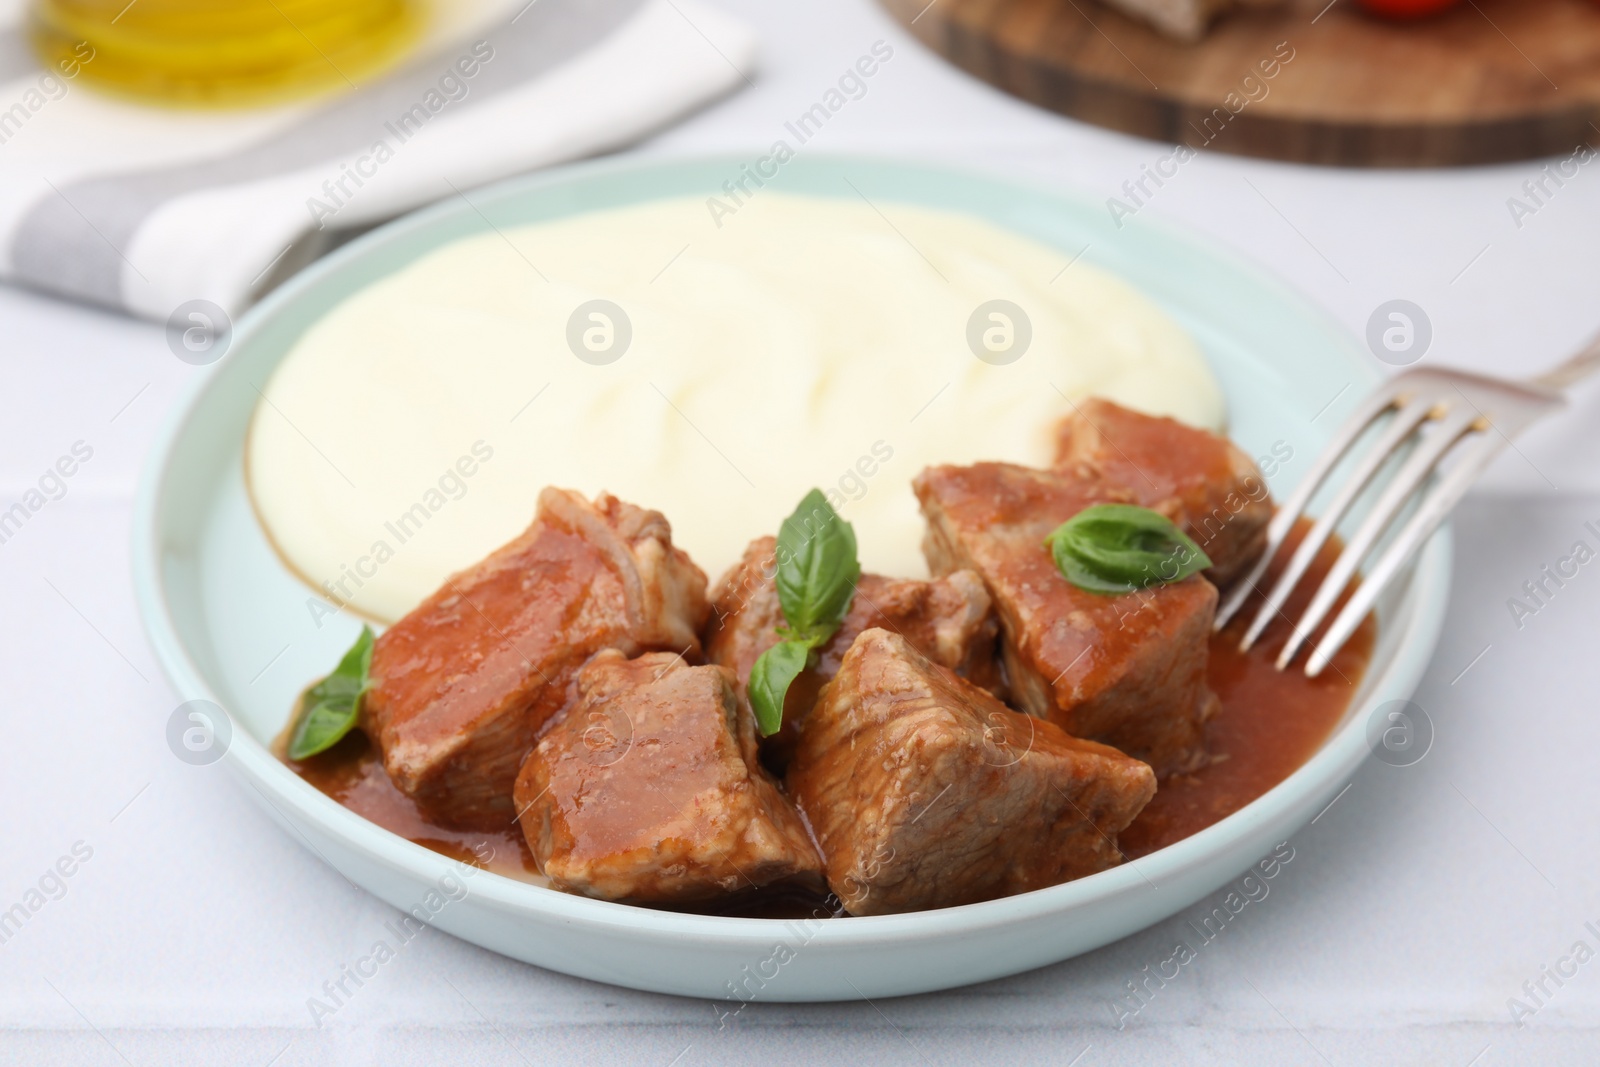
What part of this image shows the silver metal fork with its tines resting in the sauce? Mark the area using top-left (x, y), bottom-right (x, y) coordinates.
top-left (1214, 336), bottom-right (1600, 678)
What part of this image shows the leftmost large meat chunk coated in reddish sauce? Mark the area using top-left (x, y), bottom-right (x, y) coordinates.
top-left (362, 490), bottom-right (709, 830)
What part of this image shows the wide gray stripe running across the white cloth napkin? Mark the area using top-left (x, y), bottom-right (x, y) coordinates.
top-left (11, 0), bottom-right (645, 307)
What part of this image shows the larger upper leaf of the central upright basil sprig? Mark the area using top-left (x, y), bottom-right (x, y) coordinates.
top-left (778, 490), bottom-right (861, 640)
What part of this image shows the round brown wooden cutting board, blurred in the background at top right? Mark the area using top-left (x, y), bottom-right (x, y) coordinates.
top-left (882, 0), bottom-right (1600, 166)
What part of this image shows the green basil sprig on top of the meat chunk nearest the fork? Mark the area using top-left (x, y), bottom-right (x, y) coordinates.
top-left (1045, 504), bottom-right (1211, 595)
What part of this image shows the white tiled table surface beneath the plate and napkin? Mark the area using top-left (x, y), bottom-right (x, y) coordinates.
top-left (0, 0), bottom-right (1600, 1067)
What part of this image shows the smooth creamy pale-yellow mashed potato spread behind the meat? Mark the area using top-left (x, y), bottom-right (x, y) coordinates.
top-left (246, 190), bottom-right (1224, 621)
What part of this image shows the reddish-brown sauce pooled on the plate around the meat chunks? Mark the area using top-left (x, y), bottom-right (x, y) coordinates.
top-left (278, 520), bottom-right (1378, 918)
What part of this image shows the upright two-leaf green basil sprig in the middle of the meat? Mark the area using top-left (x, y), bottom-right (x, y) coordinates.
top-left (746, 490), bottom-right (861, 737)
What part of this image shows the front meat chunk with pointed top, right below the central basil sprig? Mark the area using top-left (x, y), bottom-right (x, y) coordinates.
top-left (789, 629), bottom-right (1155, 915)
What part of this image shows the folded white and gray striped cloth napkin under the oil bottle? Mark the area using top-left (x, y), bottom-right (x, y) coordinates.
top-left (0, 0), bottom-right (755, 320)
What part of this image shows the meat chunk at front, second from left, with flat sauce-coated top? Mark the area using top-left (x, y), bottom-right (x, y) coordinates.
top-left (517, 651), bottom-right (821, 904)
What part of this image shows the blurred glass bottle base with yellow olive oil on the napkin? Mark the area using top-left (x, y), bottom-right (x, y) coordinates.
top-left (30, 0), bottom-right (422, 107)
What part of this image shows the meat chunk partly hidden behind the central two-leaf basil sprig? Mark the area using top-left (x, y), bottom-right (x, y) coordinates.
top-left (706, 537), bottom-right (1005, 769)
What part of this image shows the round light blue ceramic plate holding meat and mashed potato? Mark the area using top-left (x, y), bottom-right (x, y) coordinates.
top-left (134, 157), bottom-right (1450, 1000)
